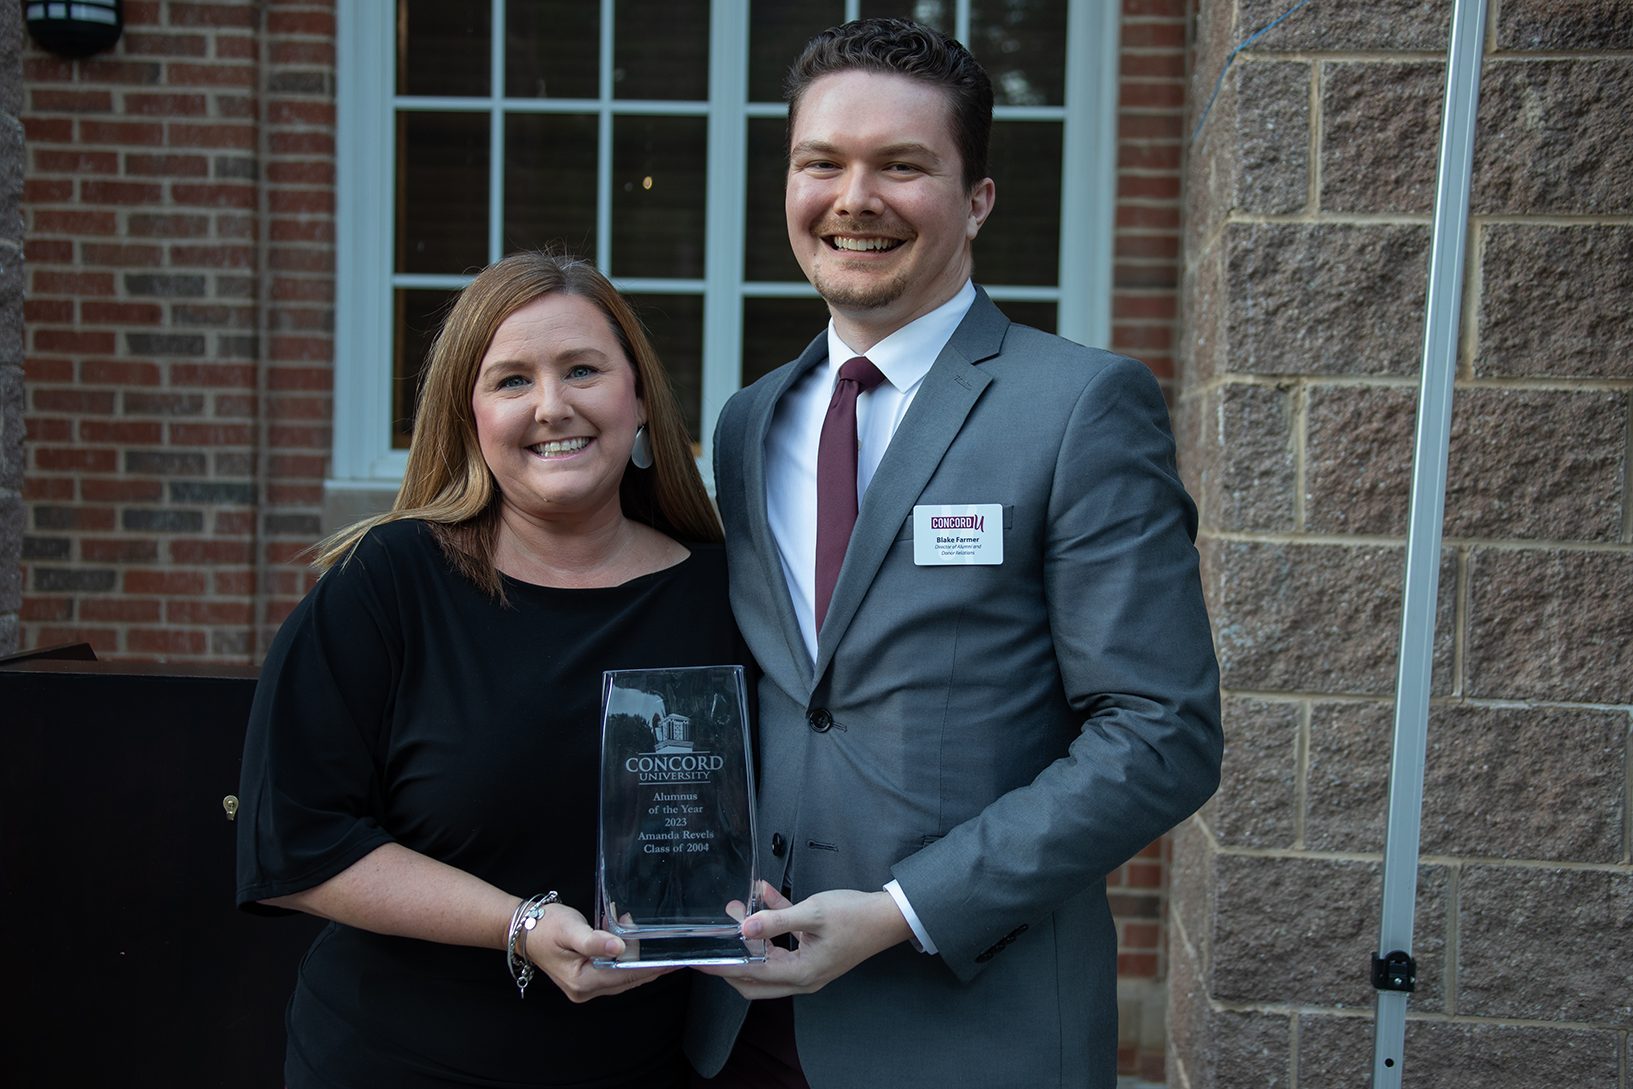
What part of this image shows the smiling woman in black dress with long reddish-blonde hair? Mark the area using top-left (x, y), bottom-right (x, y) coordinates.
top-left (237, 253), bottom-right (743, 1089)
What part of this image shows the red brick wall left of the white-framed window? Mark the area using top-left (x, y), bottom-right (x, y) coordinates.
top-left (20, 0), bottom-right (335, 663)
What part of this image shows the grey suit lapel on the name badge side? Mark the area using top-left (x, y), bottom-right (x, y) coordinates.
top-left (815, 289), bottom-right (1009, 678)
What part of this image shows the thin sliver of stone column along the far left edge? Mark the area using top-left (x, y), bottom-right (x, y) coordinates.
top-left (0, 3), bottom-right (23, 655)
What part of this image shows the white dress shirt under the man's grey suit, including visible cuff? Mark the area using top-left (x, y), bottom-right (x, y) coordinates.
top-left (766, 281), bottom-right (975, 953)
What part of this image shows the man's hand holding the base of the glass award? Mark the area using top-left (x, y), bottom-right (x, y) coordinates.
top-left (699, 885), bottom-right (911, 999)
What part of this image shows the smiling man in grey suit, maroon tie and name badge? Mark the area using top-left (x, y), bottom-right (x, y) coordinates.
top-left (689, 20), bottom-right (1220, 1089)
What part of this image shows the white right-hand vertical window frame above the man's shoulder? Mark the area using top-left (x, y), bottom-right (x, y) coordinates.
top-left (1057, 0), bottom-right (1122, 346)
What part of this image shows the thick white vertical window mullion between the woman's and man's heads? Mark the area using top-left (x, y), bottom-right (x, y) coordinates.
top-left (696, 0), bottom-right (748, 491)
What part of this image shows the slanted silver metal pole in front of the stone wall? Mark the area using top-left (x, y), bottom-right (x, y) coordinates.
top-left (1372, 0), bottom-right (1486, 1089)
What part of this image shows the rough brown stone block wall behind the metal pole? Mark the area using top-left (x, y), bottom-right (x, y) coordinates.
top-left (1169, 0), bottom-right (1633, 1089)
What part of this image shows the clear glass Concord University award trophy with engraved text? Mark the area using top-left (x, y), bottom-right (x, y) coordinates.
top-left (593, 666), bottom-right (766, 968)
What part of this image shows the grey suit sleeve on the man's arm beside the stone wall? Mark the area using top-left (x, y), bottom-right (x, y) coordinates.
top-left (893, 359), bottom-right (1221, 980)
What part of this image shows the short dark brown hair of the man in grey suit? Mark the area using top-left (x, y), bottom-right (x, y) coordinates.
top-left (782, 20), bottom-right (993, 189)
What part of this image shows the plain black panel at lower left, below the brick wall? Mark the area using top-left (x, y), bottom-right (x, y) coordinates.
top-left (0, 661), bottom-right (322, 1089)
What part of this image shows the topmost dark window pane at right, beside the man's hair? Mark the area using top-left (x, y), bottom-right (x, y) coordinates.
top-left (967, 0), bottom-right (1066, 106)
